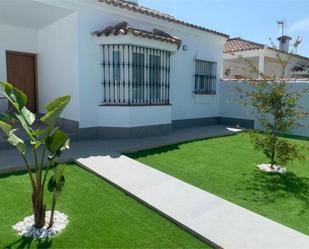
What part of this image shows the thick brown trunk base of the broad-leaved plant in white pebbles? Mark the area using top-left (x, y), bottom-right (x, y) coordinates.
top-left (32, 186), bottom-right (46, 229)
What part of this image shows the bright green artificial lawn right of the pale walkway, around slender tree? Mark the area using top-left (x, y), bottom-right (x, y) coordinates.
top-left (128, 133), bottom-right (309, 235)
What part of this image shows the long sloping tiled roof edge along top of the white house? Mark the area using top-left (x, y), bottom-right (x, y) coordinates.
top-left (98, 0), bottom-right (229, 38)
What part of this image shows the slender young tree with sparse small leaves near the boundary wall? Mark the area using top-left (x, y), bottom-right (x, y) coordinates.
top-left (237, 43), bottom-right (309, 169)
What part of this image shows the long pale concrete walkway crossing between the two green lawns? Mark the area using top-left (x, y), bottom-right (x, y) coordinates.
top-left (77, 154), bottom-right (309, 249)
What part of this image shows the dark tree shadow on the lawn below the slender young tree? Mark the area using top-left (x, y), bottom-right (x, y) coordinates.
top-left (241, 170), bottom-right (309, 213)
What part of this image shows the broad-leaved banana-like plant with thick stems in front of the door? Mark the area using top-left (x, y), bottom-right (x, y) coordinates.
top-left (0, 82), bottom-right (70, 229)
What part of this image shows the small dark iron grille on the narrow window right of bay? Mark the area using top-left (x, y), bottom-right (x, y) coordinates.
top-left (194, 60), bottom-right (217, 94)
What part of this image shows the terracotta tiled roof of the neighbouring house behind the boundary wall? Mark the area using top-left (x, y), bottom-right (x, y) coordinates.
top-left (224, 37), bottom-right (309, 60)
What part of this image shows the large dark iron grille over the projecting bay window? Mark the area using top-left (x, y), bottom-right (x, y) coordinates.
top-left (102, 45), bottom-right (171, 105)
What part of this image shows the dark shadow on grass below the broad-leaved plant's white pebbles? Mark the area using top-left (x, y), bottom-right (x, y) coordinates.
top-left (4, 237), bottom-right (52, 249)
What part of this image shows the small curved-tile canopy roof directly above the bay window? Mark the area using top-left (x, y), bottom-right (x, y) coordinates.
top-left (93, 22), bottom-right (182, 48)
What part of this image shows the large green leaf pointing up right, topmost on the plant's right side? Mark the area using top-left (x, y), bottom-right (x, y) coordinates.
top-left (41, 96), bottom-right (71, 125)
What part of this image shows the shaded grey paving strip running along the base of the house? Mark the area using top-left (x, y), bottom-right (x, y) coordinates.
top-left (0, 125), bottom-right (236, 174)
